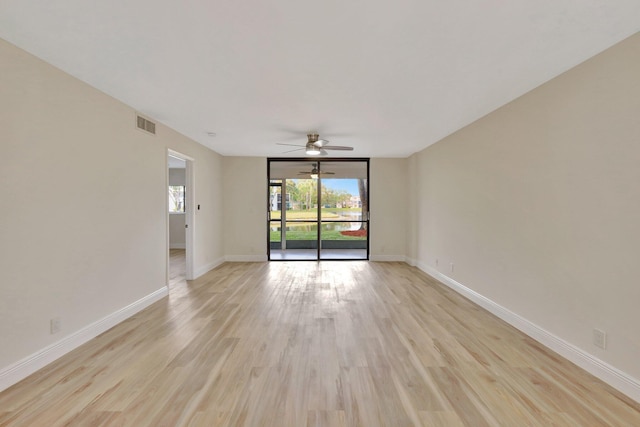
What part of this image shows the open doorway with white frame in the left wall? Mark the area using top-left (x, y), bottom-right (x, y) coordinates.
top-left (166, 150), bottom-right (194, 287)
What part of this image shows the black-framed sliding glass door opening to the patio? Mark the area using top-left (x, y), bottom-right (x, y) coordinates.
top-left (267, 158), bottom-right (370, 261)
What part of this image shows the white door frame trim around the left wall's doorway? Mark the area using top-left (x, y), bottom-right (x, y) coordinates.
top-left (164, 148), bottom-right (196, 286)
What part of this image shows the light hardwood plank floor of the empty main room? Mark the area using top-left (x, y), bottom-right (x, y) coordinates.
top-left (0, 261), bottom-right (640, 427)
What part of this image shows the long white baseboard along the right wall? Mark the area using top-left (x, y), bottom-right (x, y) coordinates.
top-left (417, 263), bottom-right (640, 403)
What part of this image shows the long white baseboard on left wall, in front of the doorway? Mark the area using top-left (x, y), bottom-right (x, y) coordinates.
top-left (0, 287), bottom-right (169, 391)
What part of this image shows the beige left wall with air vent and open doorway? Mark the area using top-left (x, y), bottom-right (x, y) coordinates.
top-left (0, 40), bottom-right (223, 371)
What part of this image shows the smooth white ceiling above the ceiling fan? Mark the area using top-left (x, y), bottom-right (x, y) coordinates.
top-left (0, 0), bottom-right (640, 157)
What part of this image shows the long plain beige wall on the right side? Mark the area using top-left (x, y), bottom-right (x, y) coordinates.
top-left (406, 34), bottom-right (640, 378)
